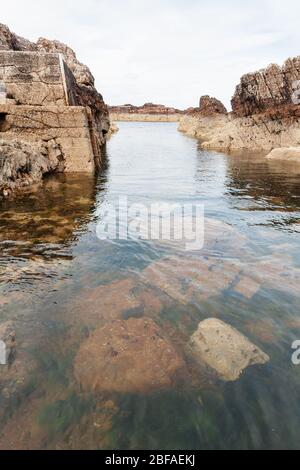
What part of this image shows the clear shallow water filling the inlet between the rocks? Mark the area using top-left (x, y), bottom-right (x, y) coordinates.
top-left (0, 123), bottom-right (300, 449)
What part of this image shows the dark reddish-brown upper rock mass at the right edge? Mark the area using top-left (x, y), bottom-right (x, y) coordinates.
top-left (232, 57), bottom-right (300, 117)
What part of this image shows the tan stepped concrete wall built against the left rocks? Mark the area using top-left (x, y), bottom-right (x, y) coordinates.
top-left (0, 51), bottom-right (102, 173)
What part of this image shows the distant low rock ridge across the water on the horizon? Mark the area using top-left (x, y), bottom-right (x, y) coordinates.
top-left (108, 103), bottom-right (184, 122)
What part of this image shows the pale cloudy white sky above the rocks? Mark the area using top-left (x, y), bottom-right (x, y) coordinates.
top-left (0, 0), bottom-right (300, 109)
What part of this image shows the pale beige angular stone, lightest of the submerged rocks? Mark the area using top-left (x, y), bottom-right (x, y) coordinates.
top-left (189, 318), bottom-right (270, 382)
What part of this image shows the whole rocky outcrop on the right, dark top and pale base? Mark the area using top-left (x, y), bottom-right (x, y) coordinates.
top-left (179, 57), bottom-right (300, 151)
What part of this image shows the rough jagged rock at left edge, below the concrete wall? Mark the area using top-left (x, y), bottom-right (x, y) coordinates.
top-left (0, 140), bottom-right (60, 196)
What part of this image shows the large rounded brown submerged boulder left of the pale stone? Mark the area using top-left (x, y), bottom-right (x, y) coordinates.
top-left (74, 318), bottom-right (187, 393)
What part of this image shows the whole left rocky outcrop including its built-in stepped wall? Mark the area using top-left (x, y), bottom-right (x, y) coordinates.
top-left (0, 24), bottom-right (110, 190)
